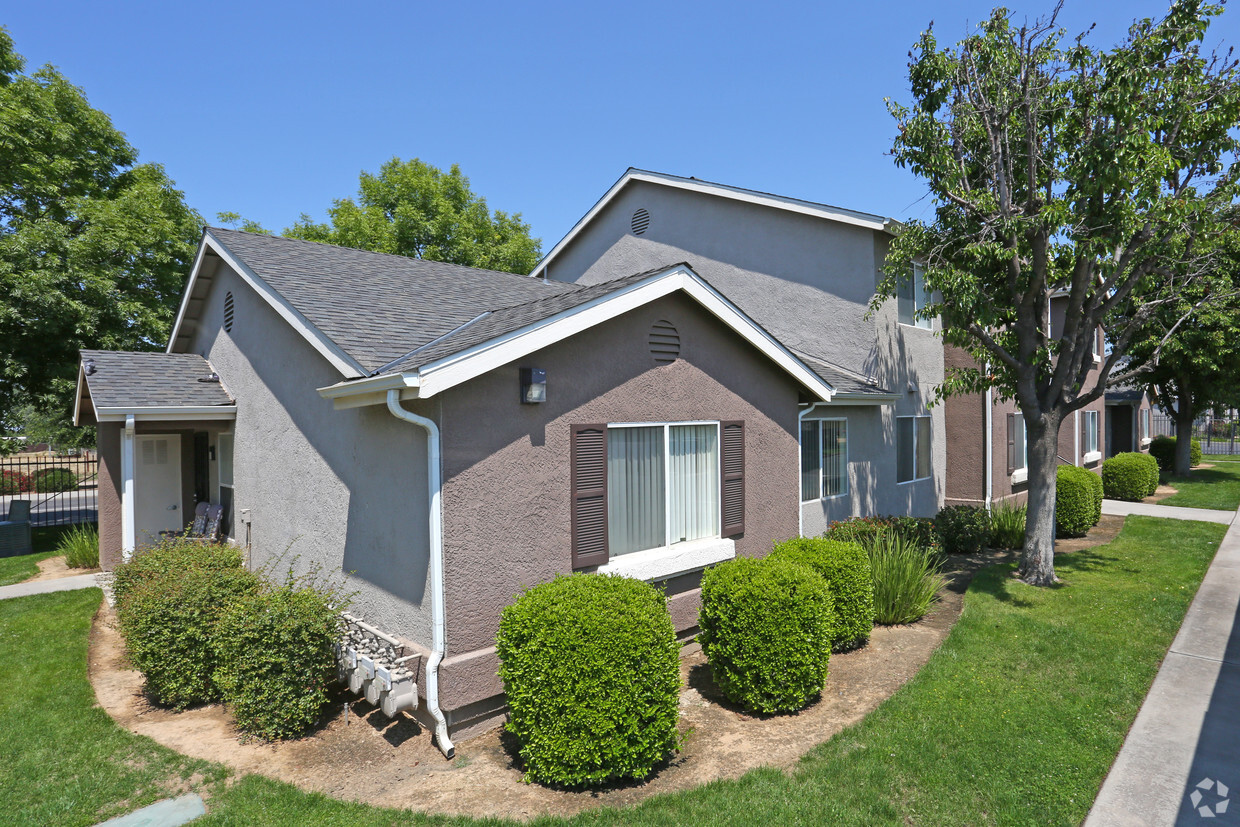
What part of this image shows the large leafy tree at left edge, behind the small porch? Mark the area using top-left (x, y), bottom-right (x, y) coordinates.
top-left (0, 29), bottom-right (202, 439)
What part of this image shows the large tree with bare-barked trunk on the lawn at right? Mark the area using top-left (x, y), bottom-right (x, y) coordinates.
top-left (875, 0), bottom-right (1240, 585)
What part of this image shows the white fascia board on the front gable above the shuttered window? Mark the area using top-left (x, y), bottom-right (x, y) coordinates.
top-left (414, 267), bottom-right (836, 402)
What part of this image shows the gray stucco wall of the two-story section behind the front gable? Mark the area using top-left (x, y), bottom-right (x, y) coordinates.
top-left (546, 182), bottom-right (946, 520)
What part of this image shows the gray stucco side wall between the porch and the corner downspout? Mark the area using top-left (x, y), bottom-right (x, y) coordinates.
top-left (179, 255), bottom-right (430, 645)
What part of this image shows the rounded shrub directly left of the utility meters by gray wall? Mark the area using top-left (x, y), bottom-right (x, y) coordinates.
top-left (215, 583), bottom-right (343, 740)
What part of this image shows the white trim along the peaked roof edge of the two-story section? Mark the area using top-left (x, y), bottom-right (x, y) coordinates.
top-left (531, 166), bottom-right (900, 280)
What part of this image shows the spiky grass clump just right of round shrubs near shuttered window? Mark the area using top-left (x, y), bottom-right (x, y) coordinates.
top-left (866, 536), bottom-right (946, 626)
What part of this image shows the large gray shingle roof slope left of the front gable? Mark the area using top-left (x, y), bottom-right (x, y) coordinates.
top-left (210, 227), bottom-right (578, 372)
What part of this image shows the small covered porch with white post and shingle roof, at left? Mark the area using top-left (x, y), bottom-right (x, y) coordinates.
top-left (74, 351), bottom-right (237, 570)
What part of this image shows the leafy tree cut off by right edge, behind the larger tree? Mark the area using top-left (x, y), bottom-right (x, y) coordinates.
top-left (1130, 223), bottom-right (1240, 476)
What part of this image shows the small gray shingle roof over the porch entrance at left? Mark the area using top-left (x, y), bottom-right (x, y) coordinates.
top-left (82, 351), bottom-right (233, 408)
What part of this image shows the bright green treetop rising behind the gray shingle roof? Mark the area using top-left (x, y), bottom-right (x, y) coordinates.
top-left (292, 157), bottom-right (542, 274)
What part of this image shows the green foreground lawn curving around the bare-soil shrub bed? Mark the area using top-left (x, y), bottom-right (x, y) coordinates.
top-left (0, 517), bottom-right (1225, 826)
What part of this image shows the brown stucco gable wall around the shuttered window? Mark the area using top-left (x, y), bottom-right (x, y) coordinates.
top-left (439, 295), bottom-right (800, 709)
